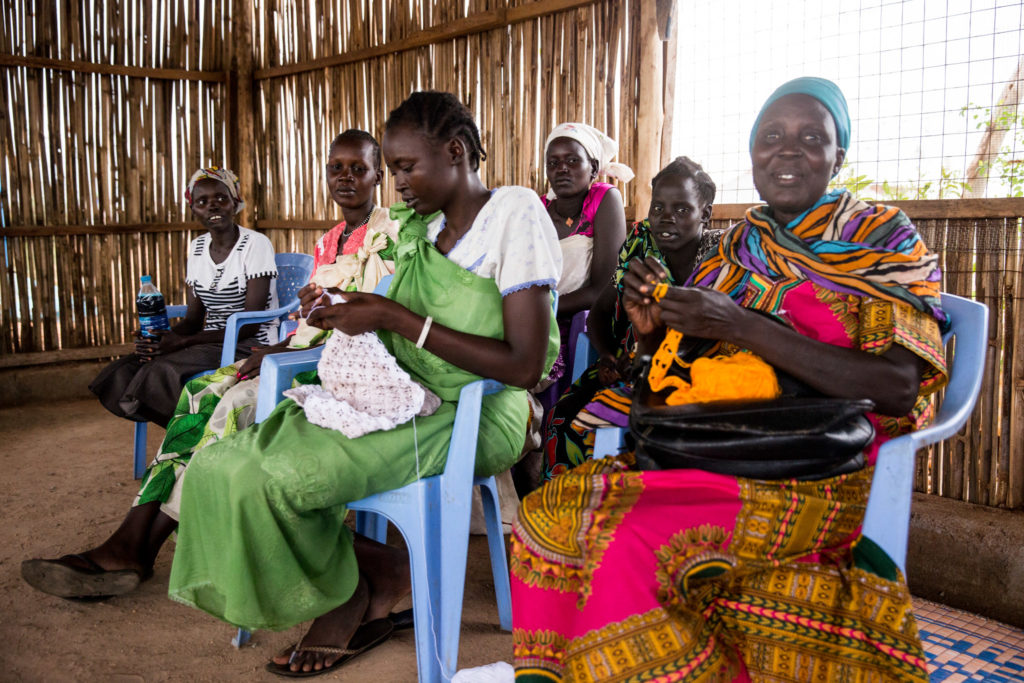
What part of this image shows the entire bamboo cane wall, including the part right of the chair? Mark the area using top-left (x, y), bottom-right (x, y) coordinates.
top-left (0, 0), bottom-right (1024, 508)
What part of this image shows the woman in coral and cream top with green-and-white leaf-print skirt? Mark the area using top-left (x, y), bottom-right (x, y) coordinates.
top-left (22, 129), bottom-right (397, 598)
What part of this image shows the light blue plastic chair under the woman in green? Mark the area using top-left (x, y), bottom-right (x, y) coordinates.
top-left (231, 275), bottom-right (512, 682)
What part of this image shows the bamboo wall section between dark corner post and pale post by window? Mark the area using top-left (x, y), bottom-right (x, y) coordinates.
top-left (253, 0), bottom-right (639, 259)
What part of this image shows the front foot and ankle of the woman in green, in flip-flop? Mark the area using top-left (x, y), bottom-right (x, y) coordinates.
top-left (273, 573), bottom-right (370, 672)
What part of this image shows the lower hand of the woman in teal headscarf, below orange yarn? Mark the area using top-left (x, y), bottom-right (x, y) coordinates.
top-left (659, 287), bottom-right (751, 342)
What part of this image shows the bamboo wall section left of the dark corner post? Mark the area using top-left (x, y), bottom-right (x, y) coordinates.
top-left (0, 0), bottom-right (230, 353)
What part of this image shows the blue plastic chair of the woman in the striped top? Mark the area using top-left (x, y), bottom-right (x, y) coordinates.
top-left (132, 253), bottom-right (313, 479)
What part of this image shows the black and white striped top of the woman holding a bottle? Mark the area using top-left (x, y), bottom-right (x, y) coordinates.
top-left (185, 226), bottom-right (278, 344)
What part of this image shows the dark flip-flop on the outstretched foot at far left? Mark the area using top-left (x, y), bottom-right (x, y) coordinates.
top-left (22, 555), bottom-right (141, 598)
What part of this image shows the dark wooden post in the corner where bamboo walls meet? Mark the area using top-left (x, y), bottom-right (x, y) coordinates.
top-left (231, 0), bottom-right (257, 227)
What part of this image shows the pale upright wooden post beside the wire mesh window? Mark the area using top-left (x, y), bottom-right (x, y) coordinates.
top-left (630, 0), bottom-right (665, 217)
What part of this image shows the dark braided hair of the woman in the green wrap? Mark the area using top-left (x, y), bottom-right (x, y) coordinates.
top-left (384, 90), bottom-right (487, 171)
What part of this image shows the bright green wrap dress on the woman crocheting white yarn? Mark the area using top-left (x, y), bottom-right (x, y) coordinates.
top-left (169, 205), bottom-right (558, 630)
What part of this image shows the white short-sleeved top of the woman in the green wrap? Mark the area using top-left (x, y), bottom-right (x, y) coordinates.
top-left (427, 185), bottom-right (562, 296)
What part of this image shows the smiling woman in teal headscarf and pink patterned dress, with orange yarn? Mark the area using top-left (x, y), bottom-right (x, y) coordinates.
top-left (511, 78), bottom-right (947, 683)
